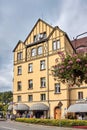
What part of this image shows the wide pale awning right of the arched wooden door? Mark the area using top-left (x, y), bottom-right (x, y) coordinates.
top-left (67, 103), bottom-right (87, 112)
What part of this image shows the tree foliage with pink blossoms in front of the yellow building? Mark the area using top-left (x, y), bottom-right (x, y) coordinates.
top-left (51, 51), bottom-right (87, 86)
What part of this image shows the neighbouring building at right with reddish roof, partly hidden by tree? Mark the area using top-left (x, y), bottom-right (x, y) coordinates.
top-left (67, 35), bottom-right (87, 120)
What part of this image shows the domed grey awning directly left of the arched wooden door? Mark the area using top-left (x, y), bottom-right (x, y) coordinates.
top-left (30, 103), bottom-right (49, 111)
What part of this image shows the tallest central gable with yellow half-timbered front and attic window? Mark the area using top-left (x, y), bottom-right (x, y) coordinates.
top-left (24, 19), bottom-right (53, 45)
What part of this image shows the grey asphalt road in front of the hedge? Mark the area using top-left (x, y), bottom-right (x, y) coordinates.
top-left (0, 120), bottom-right (83, 130)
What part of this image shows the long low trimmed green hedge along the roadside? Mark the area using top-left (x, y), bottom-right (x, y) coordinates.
top-left (16, 118), bottom-right (87, 127)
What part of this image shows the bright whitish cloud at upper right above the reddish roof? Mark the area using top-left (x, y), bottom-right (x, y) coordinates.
top-left (55, 0), bottom-right (87, 39)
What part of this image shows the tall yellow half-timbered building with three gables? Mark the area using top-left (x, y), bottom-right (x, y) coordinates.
top-left (13, 19), bottom-right (77, 119)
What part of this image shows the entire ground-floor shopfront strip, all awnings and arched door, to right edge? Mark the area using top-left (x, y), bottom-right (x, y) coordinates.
top-left (8, 99), bottom-right (87, 120)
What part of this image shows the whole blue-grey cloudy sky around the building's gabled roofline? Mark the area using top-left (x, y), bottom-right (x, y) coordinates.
top-left (0, 0), bottom-right (87, 92)
